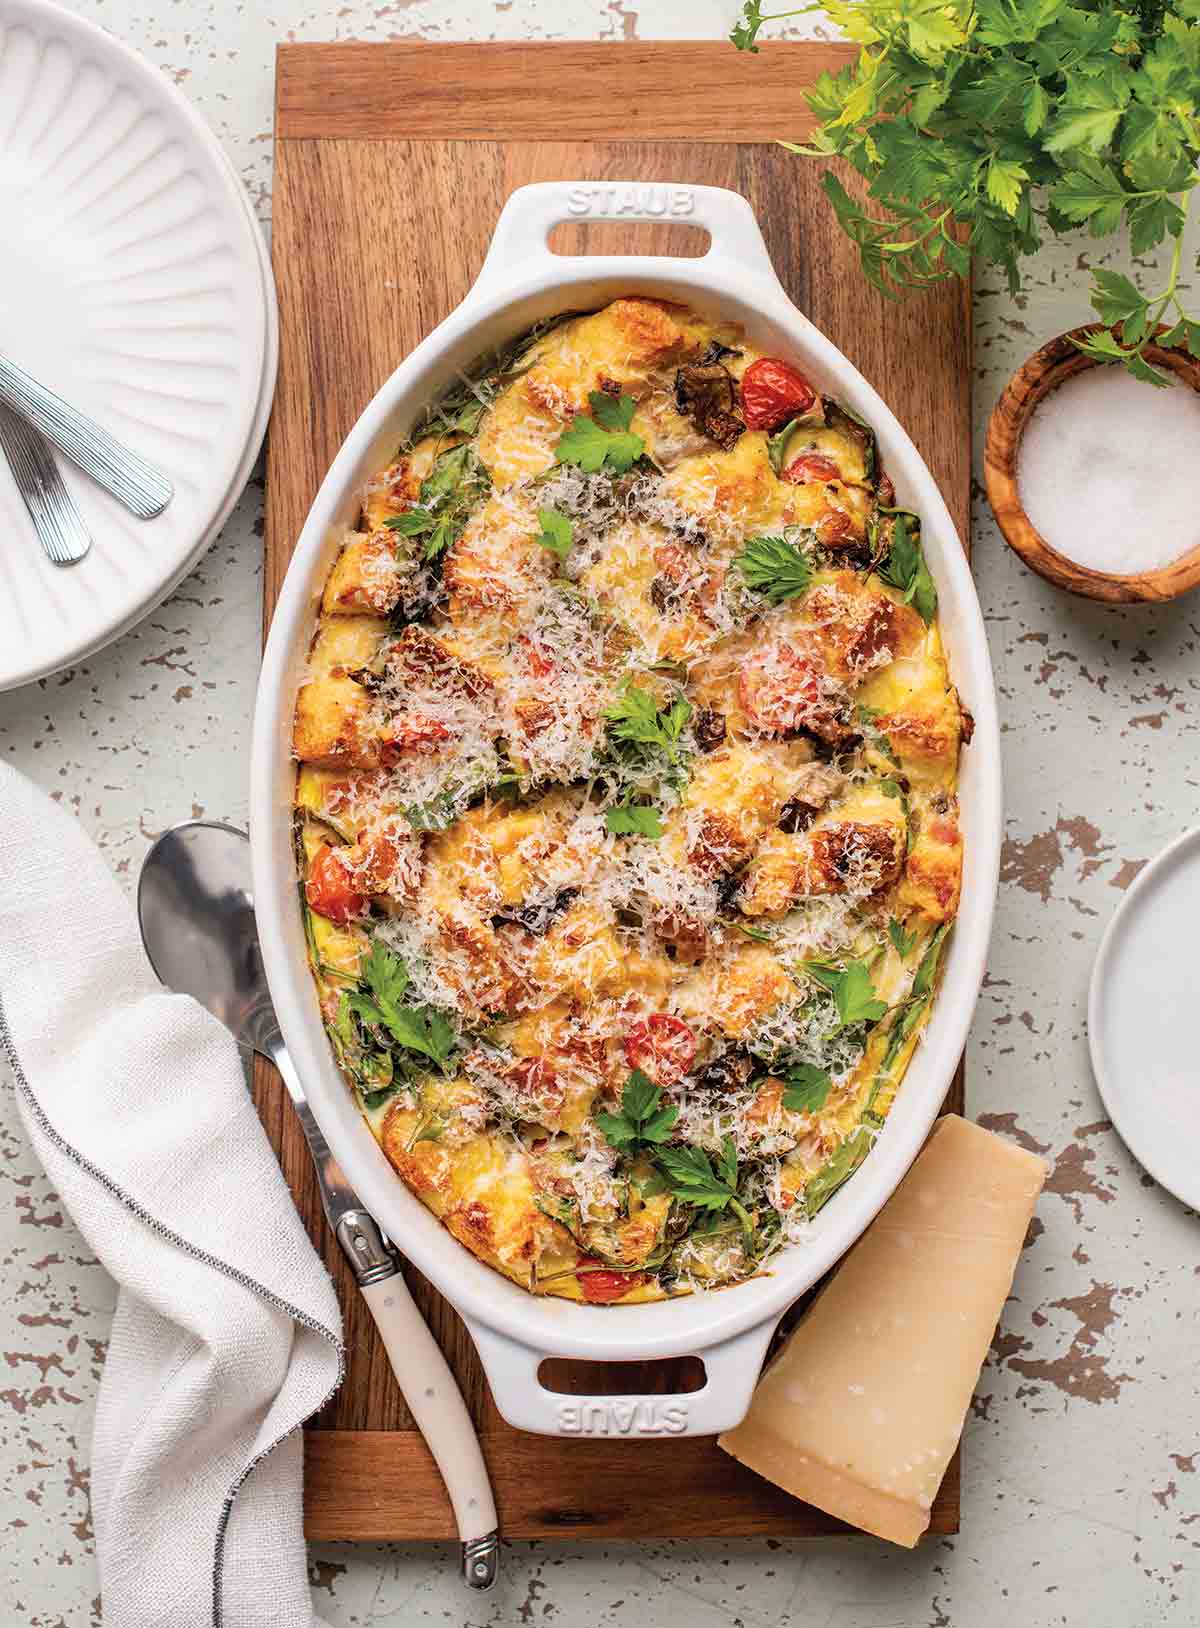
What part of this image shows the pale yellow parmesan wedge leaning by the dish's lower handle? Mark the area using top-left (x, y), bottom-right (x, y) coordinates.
top-left (720, 1114), bottom-right (1047, 1548)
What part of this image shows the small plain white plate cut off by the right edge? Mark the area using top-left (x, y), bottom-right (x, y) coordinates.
top-left (1088, 830), bottom-right (1200, 1210)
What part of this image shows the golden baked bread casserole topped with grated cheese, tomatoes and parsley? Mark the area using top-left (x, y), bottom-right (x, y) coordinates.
top-left (293, 296), bottom-right (966, 1304)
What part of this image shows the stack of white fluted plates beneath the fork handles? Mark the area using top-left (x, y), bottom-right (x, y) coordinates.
top-left (0, 0), bottom-right (277, 690)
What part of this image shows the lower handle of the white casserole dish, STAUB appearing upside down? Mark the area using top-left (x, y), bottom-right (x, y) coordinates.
top-left (467, 1312), bottom-right (778, 1441)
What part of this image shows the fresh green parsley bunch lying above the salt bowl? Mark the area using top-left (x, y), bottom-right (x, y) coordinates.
top-left (731, 0), bottom-right (1200, 384)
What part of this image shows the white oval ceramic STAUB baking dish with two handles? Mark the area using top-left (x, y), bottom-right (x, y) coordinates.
top-left (251, 182), bottom-right (1001, 1436)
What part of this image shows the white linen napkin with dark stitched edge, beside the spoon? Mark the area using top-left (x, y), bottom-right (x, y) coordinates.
top-left (0, 765), bottom-right (342, 1628)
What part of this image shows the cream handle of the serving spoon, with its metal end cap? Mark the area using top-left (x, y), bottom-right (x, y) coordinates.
top-left (361, 1271), bottom-right (498, 1589)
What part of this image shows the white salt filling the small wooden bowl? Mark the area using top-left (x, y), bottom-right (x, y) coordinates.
top-left (1018, 366), bottom-right (1200, 575)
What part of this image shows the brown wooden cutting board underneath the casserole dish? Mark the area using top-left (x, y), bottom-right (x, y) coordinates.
top-left (256, 42), bottom-right (970, 1540)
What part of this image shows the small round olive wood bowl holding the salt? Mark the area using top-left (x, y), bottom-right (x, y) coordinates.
top-left (983, 322), bottom-right (1200, 604)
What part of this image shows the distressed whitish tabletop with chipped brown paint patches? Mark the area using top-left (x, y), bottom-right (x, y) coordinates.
top-left (0, 0), bottom-right (1200, 1628)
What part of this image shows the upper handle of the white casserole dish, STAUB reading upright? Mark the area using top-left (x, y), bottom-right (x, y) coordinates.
top-left (471, 181), bottom-right (780, 295)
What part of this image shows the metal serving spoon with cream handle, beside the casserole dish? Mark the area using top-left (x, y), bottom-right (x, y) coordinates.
top-left (137, 821), bottom-right (500, 1589)
